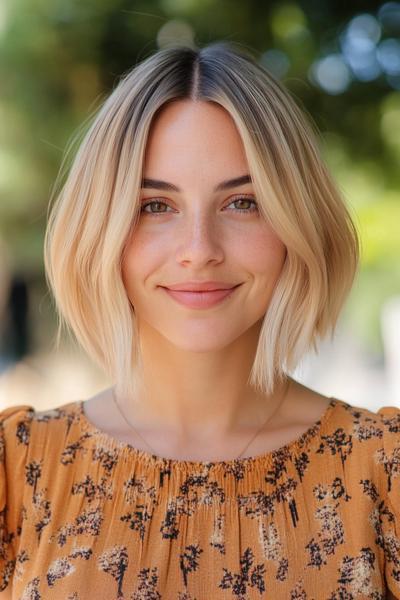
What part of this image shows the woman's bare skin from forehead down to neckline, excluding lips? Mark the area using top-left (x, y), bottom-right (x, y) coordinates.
top-left (85, 100), bottom-right (329, 460)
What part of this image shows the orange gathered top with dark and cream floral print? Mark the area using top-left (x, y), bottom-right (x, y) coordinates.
top-left (0, 398), bottom-right (400, 600)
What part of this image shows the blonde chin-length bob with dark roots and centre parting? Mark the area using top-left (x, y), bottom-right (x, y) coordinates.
top-left (44, 42), bottom-right (359, 398)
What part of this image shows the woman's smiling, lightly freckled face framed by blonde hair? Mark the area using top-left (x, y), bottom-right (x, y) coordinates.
top-left (122, 100), bottom-right (286, 352)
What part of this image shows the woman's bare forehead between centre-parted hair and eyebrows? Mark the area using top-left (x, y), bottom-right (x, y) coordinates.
top-left (144, 100), bottom-right (247, 176)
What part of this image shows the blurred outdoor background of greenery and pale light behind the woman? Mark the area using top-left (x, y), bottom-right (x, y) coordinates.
top-left (0, 0), bottom-right (400, 410)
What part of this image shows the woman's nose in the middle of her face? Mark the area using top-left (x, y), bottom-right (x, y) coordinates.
top-left (176, 211), bottom-right (224, 268)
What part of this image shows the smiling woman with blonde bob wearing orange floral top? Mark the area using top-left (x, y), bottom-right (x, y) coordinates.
top-left (0, 43), bottom-right (400, 600)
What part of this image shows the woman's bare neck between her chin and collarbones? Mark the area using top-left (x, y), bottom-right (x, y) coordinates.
top-left (115, 324), bottom-right (286, 440)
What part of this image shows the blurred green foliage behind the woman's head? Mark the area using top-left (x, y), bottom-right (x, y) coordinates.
top-left (0, 0), bottom-right (400, 352)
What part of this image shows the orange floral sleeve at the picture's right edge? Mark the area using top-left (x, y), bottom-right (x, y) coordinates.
top-left (375, 406), bottom-right (400, 599)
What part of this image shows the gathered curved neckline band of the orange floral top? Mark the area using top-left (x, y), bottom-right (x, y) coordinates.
top-left (74, 396), bottom-right (346, 469)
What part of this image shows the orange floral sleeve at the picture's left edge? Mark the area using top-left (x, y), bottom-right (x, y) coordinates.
top-left (0, 405), bottom-right (32, 593)
